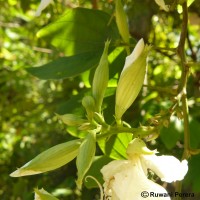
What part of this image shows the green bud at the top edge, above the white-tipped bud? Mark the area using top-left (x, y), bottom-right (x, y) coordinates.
top-left (115, 0), bottom-right (130, 54)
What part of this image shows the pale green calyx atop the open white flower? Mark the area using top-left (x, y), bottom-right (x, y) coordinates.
top-left (126, 138), bottom-right (156, 158)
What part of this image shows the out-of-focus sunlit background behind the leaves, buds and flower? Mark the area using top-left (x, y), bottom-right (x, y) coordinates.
top-left (0, 0), bottom-right (200, 200)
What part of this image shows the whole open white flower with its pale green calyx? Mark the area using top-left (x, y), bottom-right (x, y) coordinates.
top-left (101, 139), bottom-right (188, 200)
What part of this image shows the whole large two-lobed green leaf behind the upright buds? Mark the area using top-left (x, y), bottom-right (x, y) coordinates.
top-left (27, 8), bottom-right (120, 80)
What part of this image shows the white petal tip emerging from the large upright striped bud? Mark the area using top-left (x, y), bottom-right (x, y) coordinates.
top-left (122, 39), bottom-right (144, 72)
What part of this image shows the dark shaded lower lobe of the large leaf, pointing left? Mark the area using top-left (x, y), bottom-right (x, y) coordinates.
top-left (26, 52), bottom-right (101, 80)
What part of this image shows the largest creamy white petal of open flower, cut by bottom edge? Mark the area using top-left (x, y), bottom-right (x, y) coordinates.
top-left (101, 158), bottom-right (170, 200)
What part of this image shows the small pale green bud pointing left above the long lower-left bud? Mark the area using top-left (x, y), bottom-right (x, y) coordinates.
top-left (57, 114), bottom-right (86, 126)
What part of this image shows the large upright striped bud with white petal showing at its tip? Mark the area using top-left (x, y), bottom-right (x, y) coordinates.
top-left (115, 39), bottom-right (150, 121)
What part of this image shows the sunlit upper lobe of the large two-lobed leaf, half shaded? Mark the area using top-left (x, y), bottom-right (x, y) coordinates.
top-left (37, 8), bottom-right (120, 55)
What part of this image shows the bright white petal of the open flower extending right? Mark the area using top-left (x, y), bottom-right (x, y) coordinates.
top-left (141, 155), bottom-right (188, 183)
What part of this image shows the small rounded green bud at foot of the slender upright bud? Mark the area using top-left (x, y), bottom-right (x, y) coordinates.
top-left (82, 96), bottom-right (95, 120)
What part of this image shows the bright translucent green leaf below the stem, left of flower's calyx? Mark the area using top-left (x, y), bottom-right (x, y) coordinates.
top-left (98, 133), bottom-right (132, 160)
